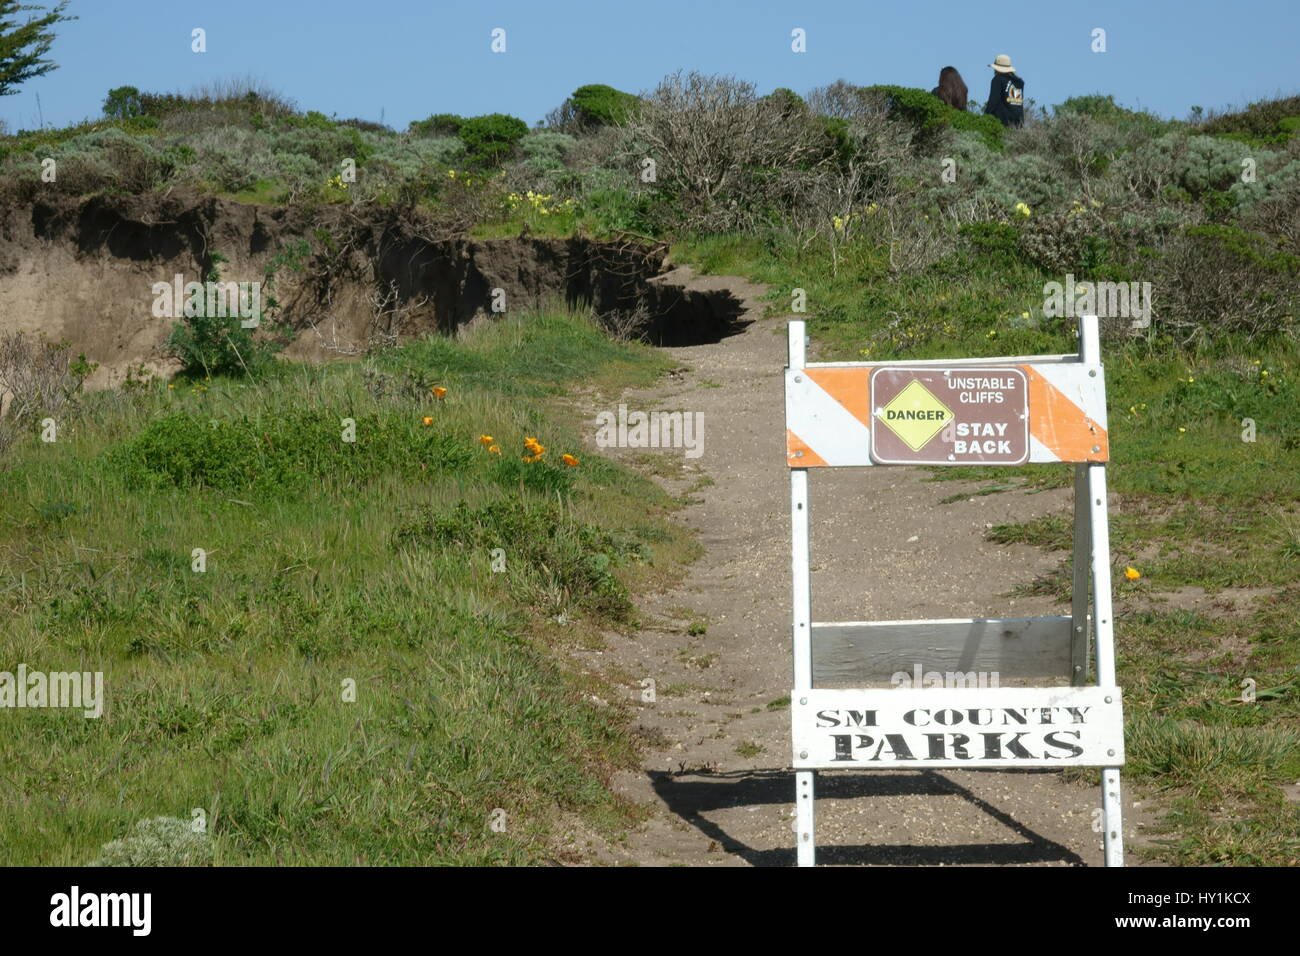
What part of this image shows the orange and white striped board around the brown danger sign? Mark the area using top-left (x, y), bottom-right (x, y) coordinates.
top-left (785, 355), bottom-right (1109, 468)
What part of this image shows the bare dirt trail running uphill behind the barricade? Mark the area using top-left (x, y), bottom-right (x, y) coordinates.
top-left (582, 269), bottom-right (1152, 866)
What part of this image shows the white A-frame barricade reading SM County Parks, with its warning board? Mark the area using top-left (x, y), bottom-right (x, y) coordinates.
top-left (785, 316), bottom-right (1125, 866)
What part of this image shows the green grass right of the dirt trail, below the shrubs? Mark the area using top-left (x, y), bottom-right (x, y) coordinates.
top-left (673, 226), bottom-right (1300, 865)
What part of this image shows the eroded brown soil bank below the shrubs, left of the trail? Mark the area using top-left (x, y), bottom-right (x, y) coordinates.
top-left (0, 191), bottom-right (741, 385)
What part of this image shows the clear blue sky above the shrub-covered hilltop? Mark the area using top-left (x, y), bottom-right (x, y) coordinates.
top-left (0, 0), bottom-right (1300, 131)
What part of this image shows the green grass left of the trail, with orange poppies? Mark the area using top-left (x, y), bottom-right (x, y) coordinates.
top-left (0, 312), bottom-right (690, 865)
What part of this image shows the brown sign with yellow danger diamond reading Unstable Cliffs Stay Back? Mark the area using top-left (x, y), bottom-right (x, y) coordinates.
top-left (870, 367), bottom-right (1030, 464)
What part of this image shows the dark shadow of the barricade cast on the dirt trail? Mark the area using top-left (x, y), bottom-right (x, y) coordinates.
top-left (647, 769), bottom-right (1086, 866)
